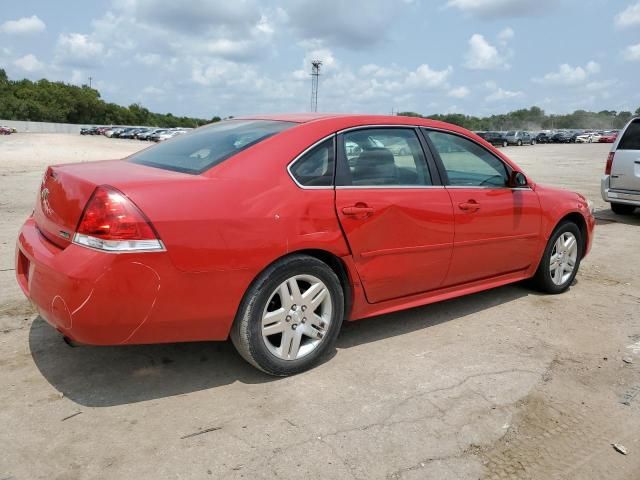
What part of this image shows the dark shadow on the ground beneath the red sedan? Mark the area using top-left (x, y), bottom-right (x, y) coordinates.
top-left (29, 284), bottom-right (537, 407)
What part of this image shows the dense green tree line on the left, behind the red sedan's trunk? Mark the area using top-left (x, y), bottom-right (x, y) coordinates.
top-left (0, 69), bottom-right (220, 127)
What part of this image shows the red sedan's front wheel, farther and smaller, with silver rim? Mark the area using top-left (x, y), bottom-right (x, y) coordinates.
top-left (533, 222), bottom-right (583, 294)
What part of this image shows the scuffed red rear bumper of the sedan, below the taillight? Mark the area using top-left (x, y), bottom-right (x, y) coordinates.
top-left (16, 218), bottom-right (243, 345)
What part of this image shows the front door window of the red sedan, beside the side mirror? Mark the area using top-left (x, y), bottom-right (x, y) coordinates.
top-left (425, 131), bottom-right (509, 187)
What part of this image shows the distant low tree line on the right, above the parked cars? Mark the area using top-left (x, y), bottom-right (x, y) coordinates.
top-left (398, 107), bottom-right (640, 131)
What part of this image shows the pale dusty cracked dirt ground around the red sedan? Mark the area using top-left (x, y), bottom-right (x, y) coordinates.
top-left (0, 134), bottom-right (640, 480)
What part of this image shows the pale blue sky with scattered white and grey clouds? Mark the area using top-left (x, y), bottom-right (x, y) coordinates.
top-left (0, 0), bottom-right (640, 118)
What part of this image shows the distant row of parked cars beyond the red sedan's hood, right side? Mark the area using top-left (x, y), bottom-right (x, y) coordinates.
top-left (476, 130), bottom-right (618, 147)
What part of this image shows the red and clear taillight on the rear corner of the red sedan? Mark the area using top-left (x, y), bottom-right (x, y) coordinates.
top-left (73, 185), bottom-right (164, 252)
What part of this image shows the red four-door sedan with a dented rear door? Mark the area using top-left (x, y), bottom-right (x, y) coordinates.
top-left (16, 115), bottom-right (594, 375)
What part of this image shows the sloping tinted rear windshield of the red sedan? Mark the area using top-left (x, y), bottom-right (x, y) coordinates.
top-left (134, 120), bottom-right (296, 174)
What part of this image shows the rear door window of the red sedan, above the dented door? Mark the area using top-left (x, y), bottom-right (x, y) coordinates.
top-left (343, 128), bottom-right (432, 186)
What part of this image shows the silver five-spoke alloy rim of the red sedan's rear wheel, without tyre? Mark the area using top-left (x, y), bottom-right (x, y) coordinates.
top-left (262, 275), bottom-right (333, 360)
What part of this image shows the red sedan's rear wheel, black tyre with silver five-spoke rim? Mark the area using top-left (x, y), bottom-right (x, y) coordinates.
top-left (231, 255), bottom-right (344, 376)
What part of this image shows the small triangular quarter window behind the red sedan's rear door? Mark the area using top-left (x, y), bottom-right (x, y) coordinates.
top-left (289, 137), bottom-right (335, 187)
